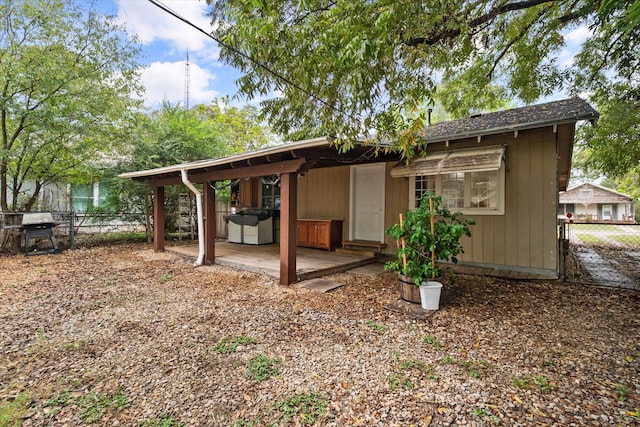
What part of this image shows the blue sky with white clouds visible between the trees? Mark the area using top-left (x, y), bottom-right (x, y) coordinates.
top-left (97, 0), bottom-right (589, 108)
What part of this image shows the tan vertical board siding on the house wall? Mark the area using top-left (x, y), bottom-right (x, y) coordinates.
top-left (298, 130), bottom-right (571, 271)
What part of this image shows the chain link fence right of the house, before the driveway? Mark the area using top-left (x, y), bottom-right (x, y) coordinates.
top-left (560, 223), bottom-right (640, 289)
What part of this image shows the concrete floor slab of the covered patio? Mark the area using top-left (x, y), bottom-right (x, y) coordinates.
top-left (165, 240), bottom-right (378, 281)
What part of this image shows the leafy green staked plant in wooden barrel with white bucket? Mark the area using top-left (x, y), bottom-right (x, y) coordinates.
top-left (385, 192), bottom-right (475, 310)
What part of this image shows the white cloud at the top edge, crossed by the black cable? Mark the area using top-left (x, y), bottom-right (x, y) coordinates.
top-left (117, 0), bottom-right (213, 52)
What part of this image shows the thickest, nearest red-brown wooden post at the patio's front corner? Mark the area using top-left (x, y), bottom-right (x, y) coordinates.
top-left (280, 173), bottom-right (298, 285)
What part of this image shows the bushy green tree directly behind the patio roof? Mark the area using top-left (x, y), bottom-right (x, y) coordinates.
top-left (109, 100), bottom-right (274, 233)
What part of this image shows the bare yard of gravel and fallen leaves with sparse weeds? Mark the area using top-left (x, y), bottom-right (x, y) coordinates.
top-left (0, 244), bottom-right (640, 426)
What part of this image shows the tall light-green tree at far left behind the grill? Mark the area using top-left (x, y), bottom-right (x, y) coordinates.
top-left (0, 0), bottom-right (140, 212)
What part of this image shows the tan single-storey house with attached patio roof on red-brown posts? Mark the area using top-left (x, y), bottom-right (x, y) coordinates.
top-left (121, 98), bottom-right (598, 284)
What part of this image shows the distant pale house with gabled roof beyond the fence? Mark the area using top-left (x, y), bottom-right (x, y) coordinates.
top-left (558, 183), bottom-right (635, 223)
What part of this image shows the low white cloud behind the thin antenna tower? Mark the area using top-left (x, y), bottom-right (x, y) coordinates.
top-left (141, 61), bottom-right (219, 107)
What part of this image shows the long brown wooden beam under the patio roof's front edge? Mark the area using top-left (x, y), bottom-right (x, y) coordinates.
top-left (146, 158), bottom-right (316, 187)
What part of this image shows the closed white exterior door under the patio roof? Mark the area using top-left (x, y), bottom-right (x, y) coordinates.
top-left (349, 163), bottom-right (386, 242)
